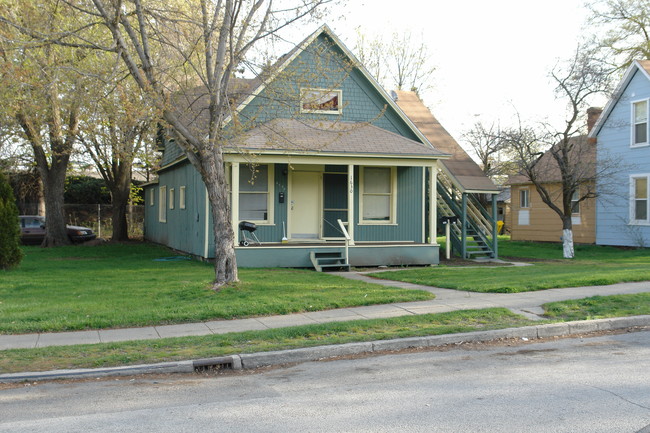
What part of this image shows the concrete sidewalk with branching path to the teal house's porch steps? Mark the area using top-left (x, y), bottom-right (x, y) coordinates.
top-left (0, 272), bottom-right (650, 350)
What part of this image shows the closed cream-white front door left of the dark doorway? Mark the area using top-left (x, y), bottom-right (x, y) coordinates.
top-left (289, 171), bottom-right (322, 241)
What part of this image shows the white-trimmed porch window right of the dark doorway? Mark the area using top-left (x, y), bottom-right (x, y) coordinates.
top-left (360, 167), bottom-right (397, 224)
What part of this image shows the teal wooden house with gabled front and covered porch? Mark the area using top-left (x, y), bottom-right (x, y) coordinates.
top-left (145, 26), bottom-right (497, 270)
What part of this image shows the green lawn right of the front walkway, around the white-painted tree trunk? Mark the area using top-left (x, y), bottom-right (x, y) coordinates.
top-left (372, 238), bottom-right (650, 293)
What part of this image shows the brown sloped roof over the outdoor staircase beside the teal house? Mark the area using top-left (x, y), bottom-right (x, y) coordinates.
top-left (395, 90), bottom-right (499, 191)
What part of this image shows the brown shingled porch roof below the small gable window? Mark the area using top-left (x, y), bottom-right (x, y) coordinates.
top-left (224, 119), bottom-right (448, 159)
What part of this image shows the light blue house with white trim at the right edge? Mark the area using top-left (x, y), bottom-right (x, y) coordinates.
top-left (590, 60), bottom-right (650, 247)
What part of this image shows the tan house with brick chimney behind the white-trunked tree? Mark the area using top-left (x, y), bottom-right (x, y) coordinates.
top-left (508, 112), bottom-right (601, 244)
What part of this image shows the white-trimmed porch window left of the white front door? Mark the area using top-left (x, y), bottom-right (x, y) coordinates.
top-left (239, 164), bottom-right (273, 224)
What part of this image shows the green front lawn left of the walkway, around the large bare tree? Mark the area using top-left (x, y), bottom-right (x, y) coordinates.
top-left (0, 243), bottom-right (433, 334)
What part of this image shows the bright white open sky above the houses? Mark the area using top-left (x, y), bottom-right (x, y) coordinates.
top-left (327, 0), bottom-right (606, 150)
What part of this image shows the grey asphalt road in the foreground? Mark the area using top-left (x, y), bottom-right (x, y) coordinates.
top-left (0, 331), bottom-right (650, 433)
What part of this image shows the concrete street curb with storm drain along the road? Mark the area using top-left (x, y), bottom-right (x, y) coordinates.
top-left (0, 315), bottom-right (650, 383)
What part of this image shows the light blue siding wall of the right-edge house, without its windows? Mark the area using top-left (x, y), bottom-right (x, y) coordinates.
top-left (596, 70), bottom-right (650, 246)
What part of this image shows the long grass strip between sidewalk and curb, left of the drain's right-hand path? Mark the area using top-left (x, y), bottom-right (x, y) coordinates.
top-left (0, 308), bottom-right (539, 373)
